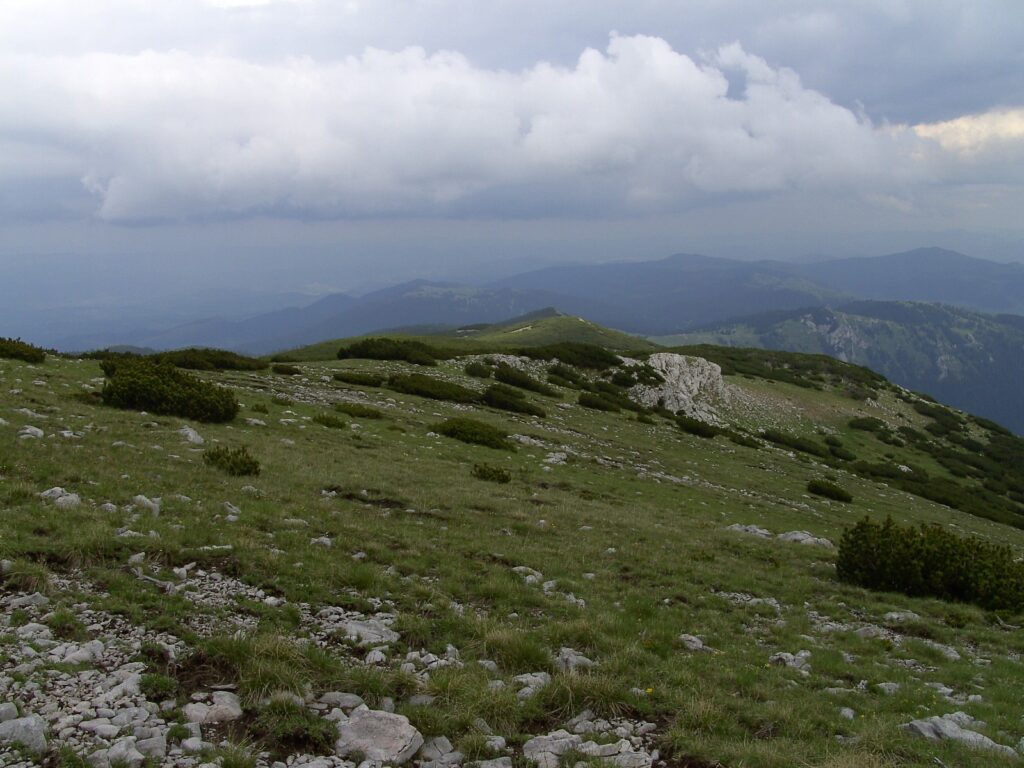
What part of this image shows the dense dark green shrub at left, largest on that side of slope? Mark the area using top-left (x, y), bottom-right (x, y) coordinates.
top-left (100, 357), bottom-right (239, 422)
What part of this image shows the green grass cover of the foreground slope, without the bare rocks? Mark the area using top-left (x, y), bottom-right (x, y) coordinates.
top-left (0, 352), bottom-right (1024, 768)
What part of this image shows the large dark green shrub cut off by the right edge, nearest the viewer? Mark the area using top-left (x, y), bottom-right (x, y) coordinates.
top-left (836, 517), bottom-right (1024, 611)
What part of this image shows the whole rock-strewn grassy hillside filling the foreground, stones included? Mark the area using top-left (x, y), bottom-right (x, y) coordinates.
top-left (0, 331), bottom-right (1024, 768)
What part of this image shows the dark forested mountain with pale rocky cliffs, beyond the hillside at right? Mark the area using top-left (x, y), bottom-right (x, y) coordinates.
top-left (655, 301), bottom-right (1024, 433)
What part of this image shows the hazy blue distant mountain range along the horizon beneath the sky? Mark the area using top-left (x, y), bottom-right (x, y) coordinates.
top-left (111, 248), bottom-right (1024, 353)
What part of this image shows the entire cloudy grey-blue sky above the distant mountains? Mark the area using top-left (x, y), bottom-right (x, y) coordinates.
top-left (0, 0), bottom-right (1024, 321)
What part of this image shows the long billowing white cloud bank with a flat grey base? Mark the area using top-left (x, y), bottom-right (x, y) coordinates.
top-left (0, 36), bottom-right (931, 221)
